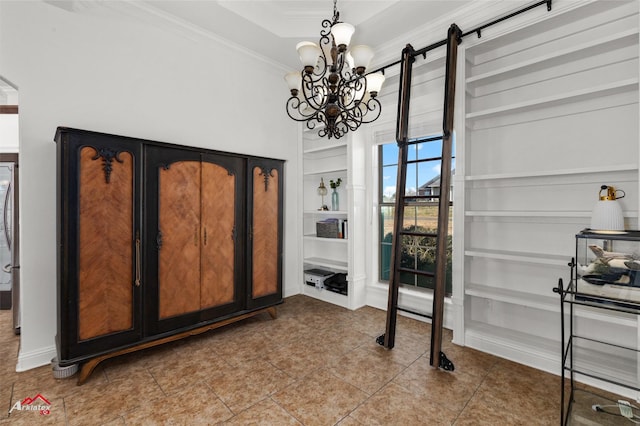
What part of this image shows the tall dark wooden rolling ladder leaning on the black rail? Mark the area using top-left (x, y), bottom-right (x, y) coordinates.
top-left (376, 24), bottom-right (462, 371)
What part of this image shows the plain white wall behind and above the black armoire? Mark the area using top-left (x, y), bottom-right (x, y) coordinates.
top-left (0, 2), bottom-right (299, 370)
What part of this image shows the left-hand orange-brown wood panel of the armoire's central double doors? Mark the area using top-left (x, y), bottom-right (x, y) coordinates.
top-left (158, 161), bottom-right (201, 318)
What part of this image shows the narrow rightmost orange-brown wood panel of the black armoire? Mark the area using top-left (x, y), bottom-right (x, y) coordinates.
top-left (251, 166), bottom-right (280, 299)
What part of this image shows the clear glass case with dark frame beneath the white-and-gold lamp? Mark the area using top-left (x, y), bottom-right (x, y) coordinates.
top-left (576, 229), bottom-right (640, 303)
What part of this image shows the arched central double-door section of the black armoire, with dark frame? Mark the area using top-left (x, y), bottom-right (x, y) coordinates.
top-left (145, 146), bottom-right (246, 335)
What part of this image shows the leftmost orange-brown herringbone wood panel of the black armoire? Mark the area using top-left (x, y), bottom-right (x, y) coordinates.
top-left (77, 146), bottom-right (135, 341)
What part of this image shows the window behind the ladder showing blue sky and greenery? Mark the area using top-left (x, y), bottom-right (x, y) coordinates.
top-left (378, 137), bottom-right (455, 295)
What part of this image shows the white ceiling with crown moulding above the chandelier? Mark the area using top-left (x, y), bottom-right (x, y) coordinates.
top-left (0, 0), bottom-right (476, 103)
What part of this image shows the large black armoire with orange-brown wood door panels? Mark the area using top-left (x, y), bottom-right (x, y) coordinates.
top-left (55, 127), bottom-right (283, 383)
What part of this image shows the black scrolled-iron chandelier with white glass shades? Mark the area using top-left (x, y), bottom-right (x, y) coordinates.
top-left (285, 0), bottom-right (384, 139)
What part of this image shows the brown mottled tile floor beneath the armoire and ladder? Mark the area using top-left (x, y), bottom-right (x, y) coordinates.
top-left (0, 296), bottom-right (612, 426)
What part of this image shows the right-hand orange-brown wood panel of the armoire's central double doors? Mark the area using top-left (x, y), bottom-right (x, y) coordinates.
top-left (200, 162), bottom-right (237, 309)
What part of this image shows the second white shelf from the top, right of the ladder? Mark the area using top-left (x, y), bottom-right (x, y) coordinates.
top-left (466, 78), bottom-right (638, 120)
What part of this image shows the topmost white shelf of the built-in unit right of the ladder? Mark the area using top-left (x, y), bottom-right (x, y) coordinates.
top-left (466, 29), bottom-right (638, 87)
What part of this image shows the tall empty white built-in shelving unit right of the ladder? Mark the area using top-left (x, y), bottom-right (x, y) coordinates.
top-left (454, 1), bottom-right (640, 382)
